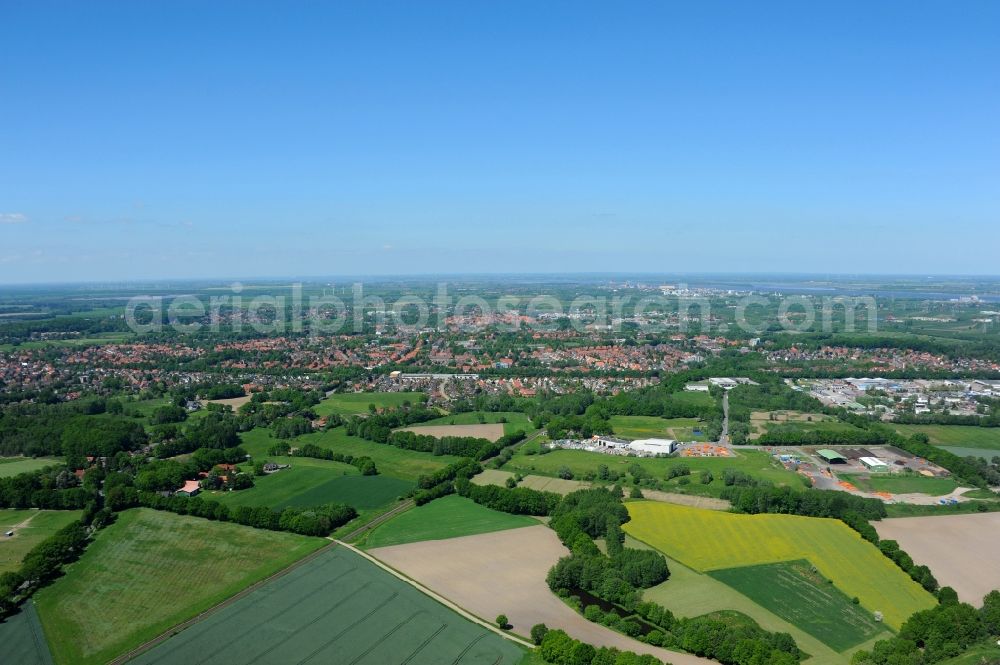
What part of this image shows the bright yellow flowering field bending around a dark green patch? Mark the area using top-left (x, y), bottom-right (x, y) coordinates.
top-left (623, 501), bottom-right (935, 629)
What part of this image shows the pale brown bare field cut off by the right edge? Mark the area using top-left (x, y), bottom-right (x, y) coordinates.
top-left (872, 513), bottom-right (1000, 607)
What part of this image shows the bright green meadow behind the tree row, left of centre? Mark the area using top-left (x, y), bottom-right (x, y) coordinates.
top-left (240, 427), bottom-right (458, 480)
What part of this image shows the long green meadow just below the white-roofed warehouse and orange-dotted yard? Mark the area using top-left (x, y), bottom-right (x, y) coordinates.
top-left (503, 446), bottom-right (804, 496)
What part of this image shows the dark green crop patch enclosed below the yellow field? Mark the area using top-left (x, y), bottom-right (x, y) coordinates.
top-left (710, 560), bottom-right (885, 652)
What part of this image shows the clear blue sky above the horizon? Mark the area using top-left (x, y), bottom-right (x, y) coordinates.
top-left (0, 0), bottom-right (1000, 283)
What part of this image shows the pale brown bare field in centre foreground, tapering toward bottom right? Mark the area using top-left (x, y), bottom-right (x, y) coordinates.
top-left (368, 526), bottom-right (718, 665)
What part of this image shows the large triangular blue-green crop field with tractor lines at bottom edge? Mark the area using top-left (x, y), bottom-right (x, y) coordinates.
top-left (126, 547), bottom-right (525, 665)
